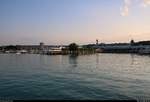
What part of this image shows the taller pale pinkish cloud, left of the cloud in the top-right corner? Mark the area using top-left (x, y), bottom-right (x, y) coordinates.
top-left (121, 0), bottom-right (131, 16)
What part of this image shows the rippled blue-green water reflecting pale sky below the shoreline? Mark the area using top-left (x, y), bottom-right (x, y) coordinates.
top-left (0, 54), bottom-right (150, 100)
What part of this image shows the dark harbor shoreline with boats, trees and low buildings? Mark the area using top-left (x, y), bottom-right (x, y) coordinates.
top-left (0, 40), bottom-right (150, 55)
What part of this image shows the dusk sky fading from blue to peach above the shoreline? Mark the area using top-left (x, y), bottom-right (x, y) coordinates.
top-left (0, 0), bottom-right (150, 45)
